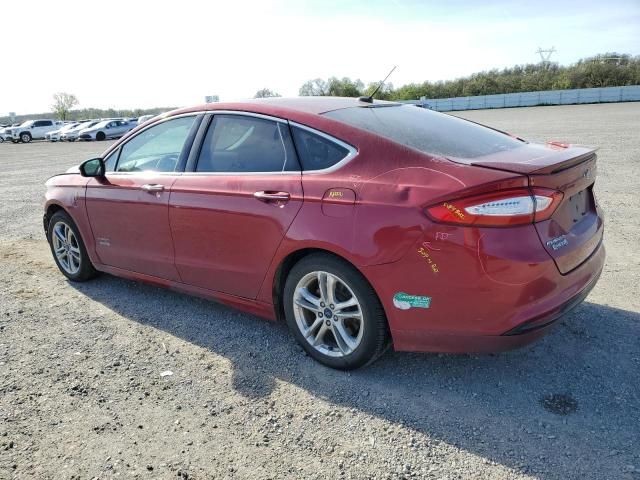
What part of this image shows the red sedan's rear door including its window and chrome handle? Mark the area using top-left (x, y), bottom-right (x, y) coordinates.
top-left (169, 113), bottom-right (303, 298)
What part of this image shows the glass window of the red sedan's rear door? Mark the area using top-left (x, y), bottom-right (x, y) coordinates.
top-left (196, 115), bottom-right (300, 172)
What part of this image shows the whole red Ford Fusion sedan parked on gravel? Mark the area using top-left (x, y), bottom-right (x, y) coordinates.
top-left (44, 97), bottom-right (605, 369)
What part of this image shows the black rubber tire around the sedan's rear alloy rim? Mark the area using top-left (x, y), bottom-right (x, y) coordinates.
top-left (282, 253), bottom-right (389, 370)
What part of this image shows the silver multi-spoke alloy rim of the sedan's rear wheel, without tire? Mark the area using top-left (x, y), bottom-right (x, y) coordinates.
top-left (293, 271), bottom-right (364, 357)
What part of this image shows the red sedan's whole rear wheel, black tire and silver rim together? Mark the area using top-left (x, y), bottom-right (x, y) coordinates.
top-left (283, 254), bottom-right (388, 370)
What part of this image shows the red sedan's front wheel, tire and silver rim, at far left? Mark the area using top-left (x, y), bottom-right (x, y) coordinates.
top-left (47, 211), bottom-right (97, 282)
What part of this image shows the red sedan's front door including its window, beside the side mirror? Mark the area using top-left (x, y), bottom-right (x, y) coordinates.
top-left (86, 115), bottom-right (199, 281)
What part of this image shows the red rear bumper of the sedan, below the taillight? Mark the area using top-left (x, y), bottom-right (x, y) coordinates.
top-left (363, 224), bottom-right (605, 353)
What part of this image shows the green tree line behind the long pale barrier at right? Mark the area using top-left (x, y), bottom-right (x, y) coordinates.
top-left (299, 53), bottom-right (640, 100)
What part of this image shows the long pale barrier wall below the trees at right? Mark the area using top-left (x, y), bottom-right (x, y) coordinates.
top-left (404, 85), bottom-right (640, 112)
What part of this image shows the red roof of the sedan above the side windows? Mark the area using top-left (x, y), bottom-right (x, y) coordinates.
top-left (168, 96), bottom-right (400, 115)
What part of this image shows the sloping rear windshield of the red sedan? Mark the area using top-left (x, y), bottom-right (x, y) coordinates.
top-left (324, 105), bottom-right (524, 158)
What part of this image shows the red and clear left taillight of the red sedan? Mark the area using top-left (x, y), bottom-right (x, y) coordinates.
top-left (426, 188), bottom-right (563, 227)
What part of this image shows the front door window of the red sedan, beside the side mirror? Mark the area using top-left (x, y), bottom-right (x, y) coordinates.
top-left (117, 116), bottom-right (196, 172)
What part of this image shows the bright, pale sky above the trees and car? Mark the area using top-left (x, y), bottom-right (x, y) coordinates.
top-left (0, 0), bottom-right (640, 116)
